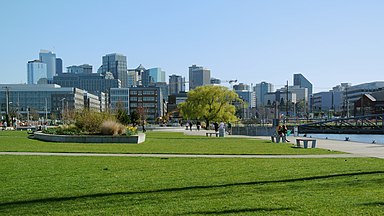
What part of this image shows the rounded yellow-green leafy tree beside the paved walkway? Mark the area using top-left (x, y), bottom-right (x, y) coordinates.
top-left (178, 86), bottom-right (241, 127)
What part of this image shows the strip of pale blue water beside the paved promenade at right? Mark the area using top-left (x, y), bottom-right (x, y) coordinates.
top-left (299, 134), bottom-right (384, 144)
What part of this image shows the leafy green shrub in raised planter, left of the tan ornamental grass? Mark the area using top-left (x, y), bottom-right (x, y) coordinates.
top-left (75, 110), bottom-right (115, 134)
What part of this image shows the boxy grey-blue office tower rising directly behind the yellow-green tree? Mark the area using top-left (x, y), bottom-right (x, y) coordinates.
top-left (189, 65), bottom-right (211, 90)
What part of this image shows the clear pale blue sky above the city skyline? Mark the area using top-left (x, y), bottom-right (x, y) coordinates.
top-left (0, 0), bottom-right (384, 92)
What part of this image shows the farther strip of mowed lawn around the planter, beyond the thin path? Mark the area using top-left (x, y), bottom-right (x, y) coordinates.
top-left (0, 131), bottom-right (338, 155)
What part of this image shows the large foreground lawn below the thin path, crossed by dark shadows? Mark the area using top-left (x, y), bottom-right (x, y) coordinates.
top-left (0, 155), bottom-right (384, 215)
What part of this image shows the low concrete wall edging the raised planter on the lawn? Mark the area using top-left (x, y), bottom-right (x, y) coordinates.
top-left (33, 132), bottom-right (145, 144)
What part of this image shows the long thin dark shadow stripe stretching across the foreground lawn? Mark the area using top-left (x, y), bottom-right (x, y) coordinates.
top-left (0, 171), bottom-right (384, 208)
